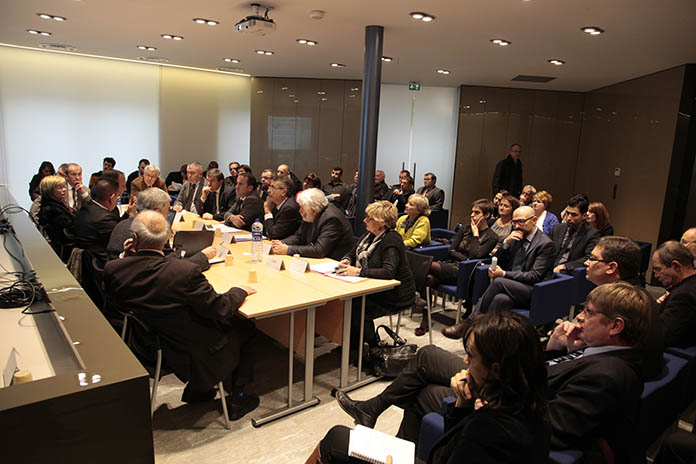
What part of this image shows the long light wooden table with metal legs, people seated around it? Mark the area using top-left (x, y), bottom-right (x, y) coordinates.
top-left (172, 212), bottom-right (400, 427)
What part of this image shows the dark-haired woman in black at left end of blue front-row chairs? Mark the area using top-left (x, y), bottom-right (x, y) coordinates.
top-left (416, 198), bottom-right (498, 337)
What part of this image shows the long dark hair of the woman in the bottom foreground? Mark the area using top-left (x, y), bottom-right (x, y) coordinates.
top-left (464, 311), bottom-right (548, 421)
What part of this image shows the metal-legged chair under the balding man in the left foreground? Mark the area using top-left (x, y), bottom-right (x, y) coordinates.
top-left (121, 311), bottom-right (230, 430)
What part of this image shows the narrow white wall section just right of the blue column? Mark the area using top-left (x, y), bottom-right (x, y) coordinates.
top-left (377, 85), bottom-right (459, 209)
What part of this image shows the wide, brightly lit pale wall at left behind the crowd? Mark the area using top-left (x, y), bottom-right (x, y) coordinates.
top-left (0, 47), bottom-right (251, 208)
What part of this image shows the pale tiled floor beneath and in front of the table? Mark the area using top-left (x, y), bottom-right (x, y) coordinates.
top-left (153, 299), bottom-right (464, 464)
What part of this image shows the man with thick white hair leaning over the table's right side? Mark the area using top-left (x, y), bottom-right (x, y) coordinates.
top-left (273, 188), bottom-right (354, 261)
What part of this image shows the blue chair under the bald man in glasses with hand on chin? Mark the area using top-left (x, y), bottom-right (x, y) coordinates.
top-left (471, 265), bottom-right (575, 325)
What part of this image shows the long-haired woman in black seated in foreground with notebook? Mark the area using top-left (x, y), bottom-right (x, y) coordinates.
top-left (307, 311), bottom-right (551, 464)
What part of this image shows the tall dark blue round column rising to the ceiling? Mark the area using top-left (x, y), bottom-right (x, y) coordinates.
top-left (353, 26), bottom-right (384, 236)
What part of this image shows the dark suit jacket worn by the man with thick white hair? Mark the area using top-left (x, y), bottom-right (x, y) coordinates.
top-left (283, 203), bottom-right (354, 260)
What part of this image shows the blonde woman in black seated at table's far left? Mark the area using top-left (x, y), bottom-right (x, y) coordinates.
top-left (39, 176), bottom-right (75, 263)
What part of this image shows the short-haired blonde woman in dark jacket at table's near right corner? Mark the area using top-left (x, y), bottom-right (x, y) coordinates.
top-left (336, 200), bottom-right (416, 346)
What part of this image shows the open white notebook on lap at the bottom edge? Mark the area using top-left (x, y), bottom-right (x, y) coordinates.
top-left (348, 425), bottom-right (416, 464)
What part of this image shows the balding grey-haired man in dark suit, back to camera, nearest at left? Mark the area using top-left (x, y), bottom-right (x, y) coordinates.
top-left (104, 211), bottom-right (259, 420)
